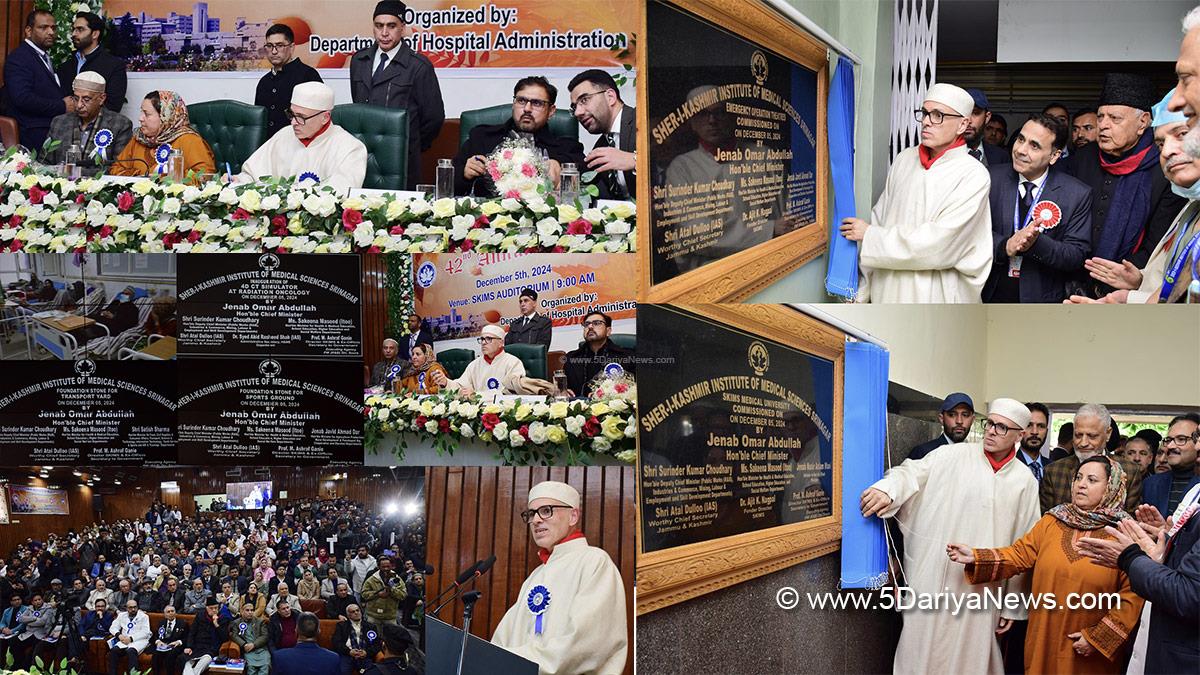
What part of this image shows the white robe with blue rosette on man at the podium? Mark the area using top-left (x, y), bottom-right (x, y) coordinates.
top-left (492, 538), bottom-right (629, 675)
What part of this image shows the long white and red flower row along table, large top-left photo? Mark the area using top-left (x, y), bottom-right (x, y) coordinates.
top-left (0, 164), bottom-right (636, 253)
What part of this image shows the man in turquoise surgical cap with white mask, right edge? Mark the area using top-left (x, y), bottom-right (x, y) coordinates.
top-left (1067, 90), bottom-right (1200, 304)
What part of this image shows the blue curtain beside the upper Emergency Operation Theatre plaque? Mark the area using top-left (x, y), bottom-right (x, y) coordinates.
top-left (826, 58), bottom-right (858, 299)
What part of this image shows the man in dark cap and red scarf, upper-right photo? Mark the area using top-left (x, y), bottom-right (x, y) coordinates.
top-left (1064, 73), bottom-right (1187, 298)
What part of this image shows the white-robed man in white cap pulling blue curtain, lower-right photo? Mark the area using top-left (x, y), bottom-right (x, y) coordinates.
top-left (862, 396), bottom-right (1042, 674)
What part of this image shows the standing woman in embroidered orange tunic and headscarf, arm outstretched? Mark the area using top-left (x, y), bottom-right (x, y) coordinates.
top-left (946, 455), bottom-right (1144, 674)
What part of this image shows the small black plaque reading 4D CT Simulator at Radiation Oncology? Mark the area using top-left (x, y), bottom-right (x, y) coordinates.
top-left (179, 252), bottom-right (362, 359)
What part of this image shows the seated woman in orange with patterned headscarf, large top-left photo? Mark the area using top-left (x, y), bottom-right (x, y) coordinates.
top-left (108, 89), bottom-right (216, 175)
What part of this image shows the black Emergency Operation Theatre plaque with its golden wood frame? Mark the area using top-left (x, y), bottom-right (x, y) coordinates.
top-left (638, 0), bottom-right (827, 301)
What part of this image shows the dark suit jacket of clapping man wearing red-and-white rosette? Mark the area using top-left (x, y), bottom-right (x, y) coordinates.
top-left (983, 165), bottom-right (1092, 303)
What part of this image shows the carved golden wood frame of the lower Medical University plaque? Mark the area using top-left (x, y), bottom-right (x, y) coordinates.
top-left (635, 305), bottom-right (846, 615)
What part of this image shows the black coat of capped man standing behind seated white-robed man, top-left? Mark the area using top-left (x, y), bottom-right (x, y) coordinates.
top-left (350, 43), bottom-right (446, 187)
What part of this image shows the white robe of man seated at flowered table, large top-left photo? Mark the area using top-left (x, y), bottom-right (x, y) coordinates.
top-left (238, 124), bottom-right (367, 190)
